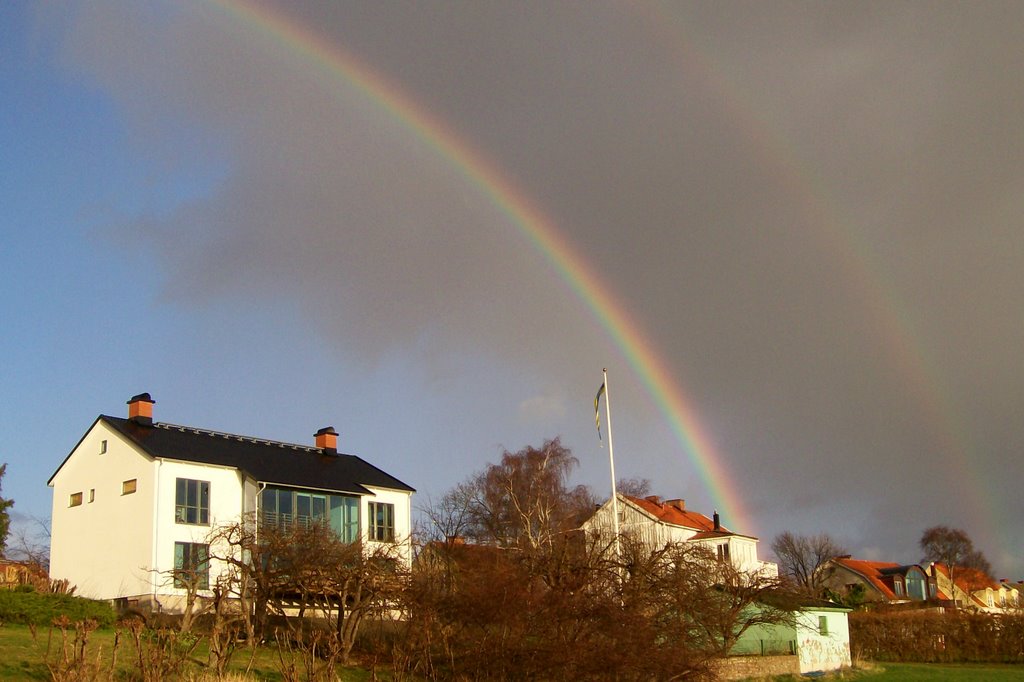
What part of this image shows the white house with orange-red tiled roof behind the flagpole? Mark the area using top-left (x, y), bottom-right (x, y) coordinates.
top-left (582, 494), bottom-right (778, 578)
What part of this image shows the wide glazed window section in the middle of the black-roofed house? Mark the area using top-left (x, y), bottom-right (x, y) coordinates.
top-left (259, 486), bottom-right (359, 543)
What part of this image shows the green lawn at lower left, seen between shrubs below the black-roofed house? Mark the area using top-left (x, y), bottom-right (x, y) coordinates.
top-left (0, 624), bottom-right (386, 682)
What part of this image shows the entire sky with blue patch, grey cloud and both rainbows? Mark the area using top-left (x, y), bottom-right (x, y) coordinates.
top-left (0, 0), bottom-right (1024, 580)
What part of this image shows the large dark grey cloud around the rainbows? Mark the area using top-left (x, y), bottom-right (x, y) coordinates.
top-left (51, 2), bottom-right (1024, 578)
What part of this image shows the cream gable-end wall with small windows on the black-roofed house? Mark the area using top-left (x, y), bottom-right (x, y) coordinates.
top-left (50, 421), bottom-right (156, 599)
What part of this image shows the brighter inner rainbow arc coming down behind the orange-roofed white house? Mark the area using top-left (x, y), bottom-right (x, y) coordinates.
top-left (209, 0), bottom-right (751, 527)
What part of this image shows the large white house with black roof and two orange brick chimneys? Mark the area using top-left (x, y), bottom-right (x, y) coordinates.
top-left (48, 393), bottom-right (415, 611)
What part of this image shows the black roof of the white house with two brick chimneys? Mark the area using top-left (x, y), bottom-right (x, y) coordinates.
top-left (95, 415), bottom-right (415, 495)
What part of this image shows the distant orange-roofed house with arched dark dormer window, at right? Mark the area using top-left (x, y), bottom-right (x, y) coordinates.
top-left (825, 555), bottom-right (938, 603)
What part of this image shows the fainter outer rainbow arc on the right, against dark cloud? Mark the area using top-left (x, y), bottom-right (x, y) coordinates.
top-left (641, 2), bottom-right (987, 547)
